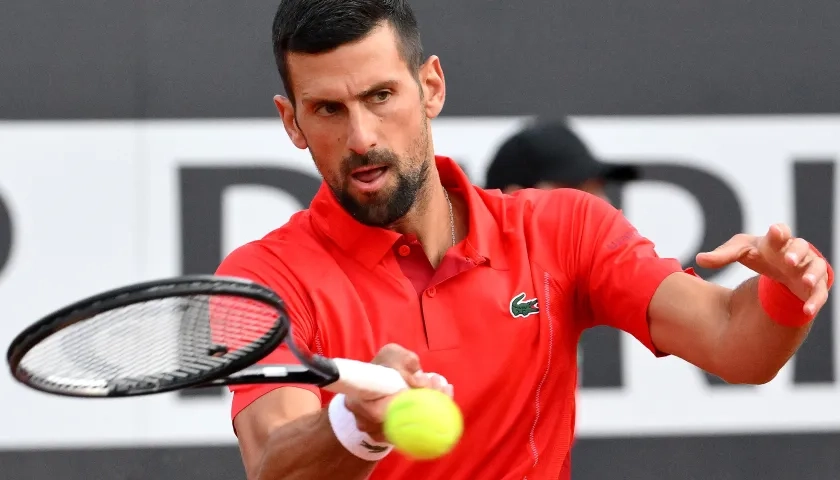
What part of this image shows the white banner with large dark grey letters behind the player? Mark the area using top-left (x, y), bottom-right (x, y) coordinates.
top-left (0, 115), bottom-right (840, 478)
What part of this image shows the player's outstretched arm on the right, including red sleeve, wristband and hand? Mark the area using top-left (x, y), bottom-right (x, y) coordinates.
top-left (556, 192), bottom-right (833, 384)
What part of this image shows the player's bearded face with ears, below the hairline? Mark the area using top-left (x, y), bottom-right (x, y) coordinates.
top-left (277, 25), bottom-right (443, 227)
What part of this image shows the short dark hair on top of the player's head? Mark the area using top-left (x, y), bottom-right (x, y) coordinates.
top-left (271, 0), bottom-right (423, 102)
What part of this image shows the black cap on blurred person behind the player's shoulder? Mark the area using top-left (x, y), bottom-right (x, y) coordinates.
top-left (485, 121), bottom-right (639, 189)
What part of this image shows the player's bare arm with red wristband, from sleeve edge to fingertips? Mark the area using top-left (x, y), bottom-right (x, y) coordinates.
top-left (648, 225), bottom-right (833, 384)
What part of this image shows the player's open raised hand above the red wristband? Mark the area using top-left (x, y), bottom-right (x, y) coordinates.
top-left (697, 223), bottom-right (828, 316)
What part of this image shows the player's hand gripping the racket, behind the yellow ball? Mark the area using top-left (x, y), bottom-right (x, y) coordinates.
top-left (344, 343), bottom-right (453, 442)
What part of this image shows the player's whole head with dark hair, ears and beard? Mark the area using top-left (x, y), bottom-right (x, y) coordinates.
top-left (272, 0), bottom-right (445, 226)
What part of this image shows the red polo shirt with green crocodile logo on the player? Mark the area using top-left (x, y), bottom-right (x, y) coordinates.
top-left (217, 157), bottom-right (681, 480)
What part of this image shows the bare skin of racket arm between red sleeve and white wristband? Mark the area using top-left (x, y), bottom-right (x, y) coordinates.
top-left (234, 387), bottom-right (376, 480)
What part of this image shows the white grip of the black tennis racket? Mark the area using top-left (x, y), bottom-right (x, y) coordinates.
top-left (323, 358), bottom-right (408, 399)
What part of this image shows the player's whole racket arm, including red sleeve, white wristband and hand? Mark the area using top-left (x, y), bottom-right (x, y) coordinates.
top-left (216, 243), bottom-right (453, 480)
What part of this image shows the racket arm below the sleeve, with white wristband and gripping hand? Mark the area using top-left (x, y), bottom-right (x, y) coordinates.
top-left (234, 344), bottom-right (446, 480)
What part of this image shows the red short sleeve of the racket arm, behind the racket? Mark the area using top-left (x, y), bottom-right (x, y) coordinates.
top-left (216, 243), bottom-right (321, 419)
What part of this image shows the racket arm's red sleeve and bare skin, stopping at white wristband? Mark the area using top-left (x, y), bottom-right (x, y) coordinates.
top-left (216, 246), bottom-right (382, 480)
